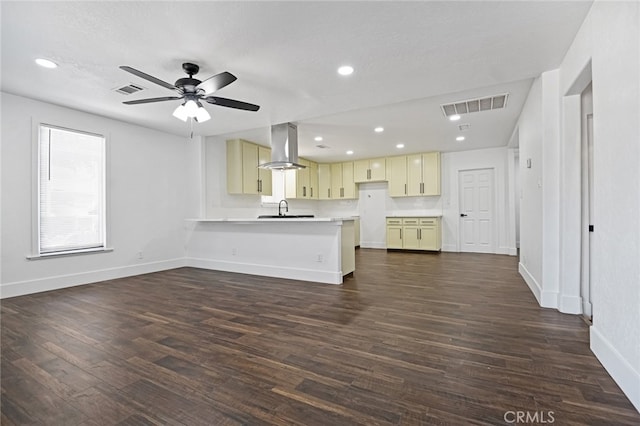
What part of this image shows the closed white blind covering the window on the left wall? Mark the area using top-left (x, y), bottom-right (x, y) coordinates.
top-left (38, 125), bottom-right (106, 254)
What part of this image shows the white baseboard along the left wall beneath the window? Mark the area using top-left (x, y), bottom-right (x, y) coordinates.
top-left (0, 258), bottom-right (186, 299)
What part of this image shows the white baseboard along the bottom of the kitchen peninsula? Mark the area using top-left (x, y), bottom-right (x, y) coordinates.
top-left (186, 257), bottom-right (342, 284)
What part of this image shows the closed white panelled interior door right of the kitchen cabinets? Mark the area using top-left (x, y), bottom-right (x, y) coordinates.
top-left (458, 169), bottom-right (495, 253)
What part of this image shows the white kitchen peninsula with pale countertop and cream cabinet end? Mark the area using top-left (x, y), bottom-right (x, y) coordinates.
top-left (187, 217), bottom-right (355, 284)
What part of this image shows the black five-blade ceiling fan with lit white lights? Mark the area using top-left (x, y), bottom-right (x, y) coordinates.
top-left (120, 62), bottom-right (260, 122)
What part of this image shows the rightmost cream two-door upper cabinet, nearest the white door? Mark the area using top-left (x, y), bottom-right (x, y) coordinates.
top-left (407, 152), bottom-right (440, 196)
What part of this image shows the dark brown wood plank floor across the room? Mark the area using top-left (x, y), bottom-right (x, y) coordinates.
top-left (1, 249), bottom-right (640, 425)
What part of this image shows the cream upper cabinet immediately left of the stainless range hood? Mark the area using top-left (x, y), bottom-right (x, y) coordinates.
top-left (227, 139), bottom-right (272, 195)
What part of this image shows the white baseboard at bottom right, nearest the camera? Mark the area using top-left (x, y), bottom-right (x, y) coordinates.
top-left (589, 325), bottom-right (640, 412)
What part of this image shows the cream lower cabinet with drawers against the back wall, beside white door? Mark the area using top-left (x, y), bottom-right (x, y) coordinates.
top-left (387, 217), bottom-right (442, 251)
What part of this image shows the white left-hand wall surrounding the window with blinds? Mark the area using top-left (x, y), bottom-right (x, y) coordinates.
top-left (0, 93), bottom-right (199, 297)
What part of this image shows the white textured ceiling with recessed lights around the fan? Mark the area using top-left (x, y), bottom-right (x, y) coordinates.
top-left (1, 1), bottom-right (591, 161)
